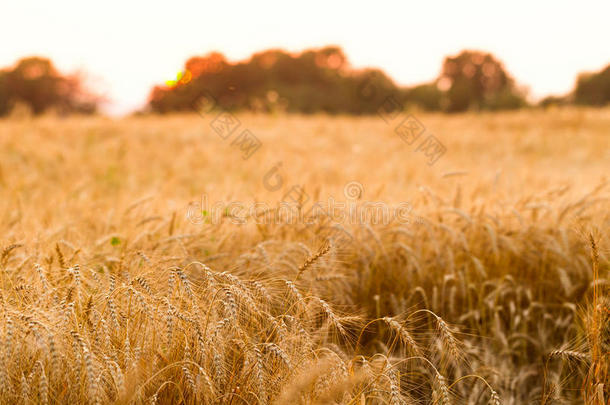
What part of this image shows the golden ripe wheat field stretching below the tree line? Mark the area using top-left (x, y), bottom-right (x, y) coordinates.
top-left (0, 109), bottom-right (610, 405)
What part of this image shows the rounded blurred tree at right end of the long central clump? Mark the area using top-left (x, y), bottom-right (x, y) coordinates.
top-left (437, 51), bottom-right (525, 112)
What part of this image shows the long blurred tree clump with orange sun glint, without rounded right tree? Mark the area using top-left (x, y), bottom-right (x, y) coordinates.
top-left (149, 46), bottom-right (404, 114)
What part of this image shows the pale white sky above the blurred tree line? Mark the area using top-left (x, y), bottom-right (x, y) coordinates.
top-left (0, 0), bottom-right (610, 115)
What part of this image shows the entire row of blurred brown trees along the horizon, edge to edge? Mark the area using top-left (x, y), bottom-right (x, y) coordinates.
top-left (0, 46), bottom-right (610, 116)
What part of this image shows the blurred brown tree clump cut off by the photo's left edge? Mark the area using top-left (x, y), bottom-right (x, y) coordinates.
top-left (0, 57), bottom-right (99, 115)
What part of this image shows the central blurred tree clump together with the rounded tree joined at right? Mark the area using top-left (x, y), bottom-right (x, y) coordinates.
top-left (149, 46), bottom-right (525, 114)
